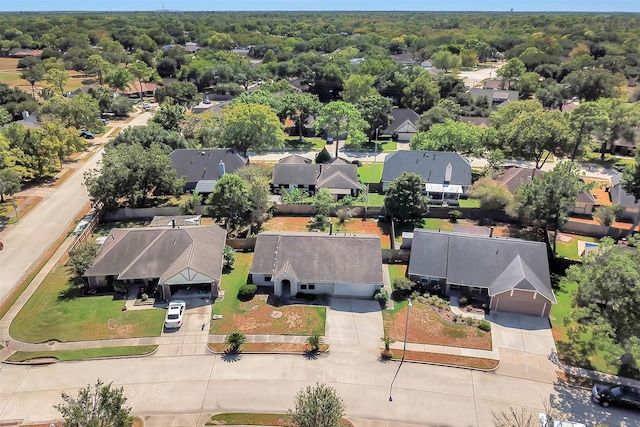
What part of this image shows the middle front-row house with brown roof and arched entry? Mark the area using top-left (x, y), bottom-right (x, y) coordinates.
top-left (249, 232), bottom-right (384, 298)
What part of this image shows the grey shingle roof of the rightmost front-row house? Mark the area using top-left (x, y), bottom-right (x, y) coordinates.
top-left (409, 229), bottom-right (556, 303)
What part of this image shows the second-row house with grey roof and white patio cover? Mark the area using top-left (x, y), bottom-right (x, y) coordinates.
top-left (382, 150), bottom-right (471, 204)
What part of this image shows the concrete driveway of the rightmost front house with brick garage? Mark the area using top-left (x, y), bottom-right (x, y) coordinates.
top-left (487, 312), bottom-right (557, 383)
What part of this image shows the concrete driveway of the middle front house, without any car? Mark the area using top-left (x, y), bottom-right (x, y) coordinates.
top-left (326, 298), bottom-right (384, 358)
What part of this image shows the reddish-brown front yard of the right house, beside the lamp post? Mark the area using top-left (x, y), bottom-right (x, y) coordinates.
top-left (383, 302), bottom-right (492, 350)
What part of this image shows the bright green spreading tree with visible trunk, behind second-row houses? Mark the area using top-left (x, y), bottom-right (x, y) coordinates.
top-left (314, 101), bottom-right (368, 157)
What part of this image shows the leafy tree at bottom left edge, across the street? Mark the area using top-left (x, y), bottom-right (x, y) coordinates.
top-left (54, 380), bottom-right (133, 427)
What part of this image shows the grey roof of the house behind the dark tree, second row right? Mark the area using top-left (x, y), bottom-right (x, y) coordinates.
top-left (382, 150), bottom-right (471, 186)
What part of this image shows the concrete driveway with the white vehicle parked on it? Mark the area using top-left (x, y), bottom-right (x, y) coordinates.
top-left (155, 298), bottom-right (211, 357)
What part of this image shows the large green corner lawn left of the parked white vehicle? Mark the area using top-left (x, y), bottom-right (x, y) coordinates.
top-left (10, 266), bottom-right (165, 343)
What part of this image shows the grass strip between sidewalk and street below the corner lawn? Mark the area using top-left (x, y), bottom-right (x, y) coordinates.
top-left (9, 345), bottom-right (158, 362)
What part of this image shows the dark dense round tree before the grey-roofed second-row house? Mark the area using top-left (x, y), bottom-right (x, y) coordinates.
top-left (384, 172), bottom-right (429, 221)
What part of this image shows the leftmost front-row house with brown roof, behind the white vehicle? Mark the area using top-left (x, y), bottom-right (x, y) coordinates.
top-left (84, 225), bottom-right (226, 301)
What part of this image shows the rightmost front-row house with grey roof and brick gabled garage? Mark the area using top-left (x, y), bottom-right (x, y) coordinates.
top-left (408, 229), bottom-right (556, 316)
